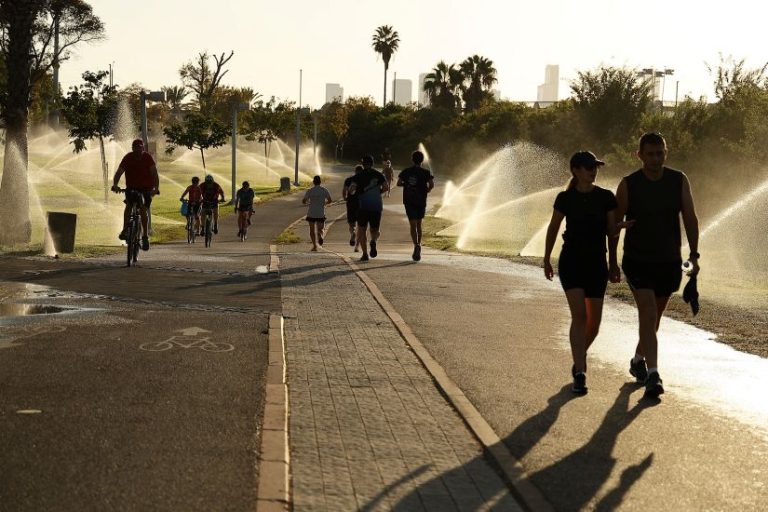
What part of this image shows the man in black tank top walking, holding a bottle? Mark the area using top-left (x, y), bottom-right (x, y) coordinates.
top-left (611, 133), bottom-right (699, 398)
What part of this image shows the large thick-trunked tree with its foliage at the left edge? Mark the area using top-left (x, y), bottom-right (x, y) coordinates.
top-left (0, 0), bottom-right (104, 244)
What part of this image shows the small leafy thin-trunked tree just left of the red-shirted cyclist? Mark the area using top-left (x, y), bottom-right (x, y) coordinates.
top-left (62, 71), bottom-right (119, 204)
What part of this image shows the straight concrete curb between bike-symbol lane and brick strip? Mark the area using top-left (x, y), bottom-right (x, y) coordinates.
top-left (256, 314), bottom-right (291, 512)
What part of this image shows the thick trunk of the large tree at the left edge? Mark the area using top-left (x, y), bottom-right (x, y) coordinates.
top-left (0, 0), bottom-right (42, 245)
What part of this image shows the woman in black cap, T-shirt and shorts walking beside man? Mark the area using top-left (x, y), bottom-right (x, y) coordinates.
top-left (544, 151), bottom-right (624, 394)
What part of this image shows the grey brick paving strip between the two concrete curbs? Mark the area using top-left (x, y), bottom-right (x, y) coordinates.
top-left (280, 253), bottom-right (521, 512)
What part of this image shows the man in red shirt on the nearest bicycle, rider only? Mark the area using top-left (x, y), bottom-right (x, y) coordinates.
top-left (112, 139), bottom-right (160, 251)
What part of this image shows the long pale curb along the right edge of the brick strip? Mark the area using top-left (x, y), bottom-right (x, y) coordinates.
top-left (325, 232), bottom-right (555, 512)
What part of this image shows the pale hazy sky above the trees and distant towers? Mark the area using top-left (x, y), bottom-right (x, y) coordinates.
top-left (61, 0), bottom-right (768, 107)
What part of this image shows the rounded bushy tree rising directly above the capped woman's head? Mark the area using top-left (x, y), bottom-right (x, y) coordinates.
top-left (571, 66), bottom-right (652, 153)
